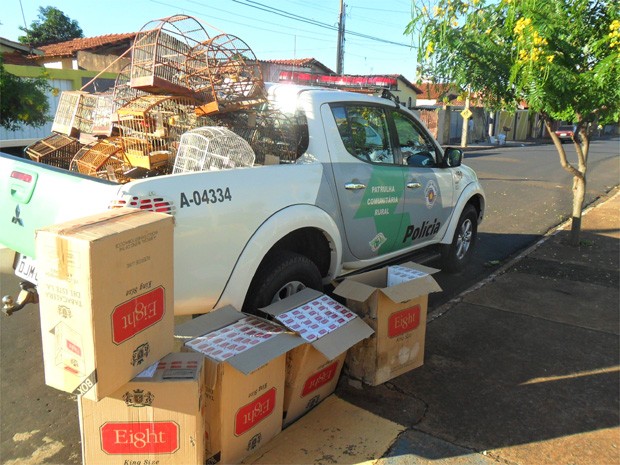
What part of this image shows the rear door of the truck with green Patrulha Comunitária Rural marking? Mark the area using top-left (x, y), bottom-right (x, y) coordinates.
top-left (321, 103), bottom-right (406, 260)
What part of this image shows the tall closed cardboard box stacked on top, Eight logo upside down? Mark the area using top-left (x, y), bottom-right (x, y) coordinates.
top-left (36, 208), bottom-right (174, 400)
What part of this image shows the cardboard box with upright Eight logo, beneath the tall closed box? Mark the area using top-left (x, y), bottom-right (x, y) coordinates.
top-left (78, 352), bottom-right (206, 465)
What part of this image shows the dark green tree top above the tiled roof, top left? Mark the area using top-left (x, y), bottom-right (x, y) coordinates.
top-left (17, 6), bottom-right (84, 47)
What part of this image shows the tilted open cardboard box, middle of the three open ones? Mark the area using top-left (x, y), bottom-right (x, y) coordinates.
top-left (261, 288), bottom-right (373, 427)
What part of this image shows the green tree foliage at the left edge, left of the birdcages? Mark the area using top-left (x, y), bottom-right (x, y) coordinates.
top-left (0, 58), bottom-right (51, 131)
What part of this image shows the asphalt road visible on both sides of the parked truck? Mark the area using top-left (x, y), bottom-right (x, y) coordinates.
top-left (0, 138), bottom-right (620, 465)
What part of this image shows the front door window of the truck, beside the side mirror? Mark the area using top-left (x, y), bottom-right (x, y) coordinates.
top-left (392, 110), bottom-right (437, 168)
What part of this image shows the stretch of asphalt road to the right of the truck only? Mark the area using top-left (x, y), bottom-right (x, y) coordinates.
top-left (429, 138), bottom-right (620, 311)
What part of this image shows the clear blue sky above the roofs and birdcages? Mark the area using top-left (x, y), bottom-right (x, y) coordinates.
top-left (0, 0), bottom-right (416, 81)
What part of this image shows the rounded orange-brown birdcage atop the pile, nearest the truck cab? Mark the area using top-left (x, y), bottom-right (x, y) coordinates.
top-left (187, 34), bottom-right (266, 115)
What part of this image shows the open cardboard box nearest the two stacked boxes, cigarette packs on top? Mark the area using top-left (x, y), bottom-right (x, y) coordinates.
top-left (175, 306), bottom-right (303, 464)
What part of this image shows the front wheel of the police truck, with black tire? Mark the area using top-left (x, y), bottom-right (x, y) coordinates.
top-left (441, 205), bottom-right (478, 273)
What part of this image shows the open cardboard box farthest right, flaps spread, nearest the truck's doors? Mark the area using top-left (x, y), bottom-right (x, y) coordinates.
top-left (334, 262), bottom-right (441, 386)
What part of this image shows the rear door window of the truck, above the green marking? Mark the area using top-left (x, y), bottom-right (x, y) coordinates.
top-left (331, 105), bottom-right (394, 164)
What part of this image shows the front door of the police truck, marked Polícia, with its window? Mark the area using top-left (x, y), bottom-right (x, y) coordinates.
top-left (392, 109), bottom-right (454, 249)
